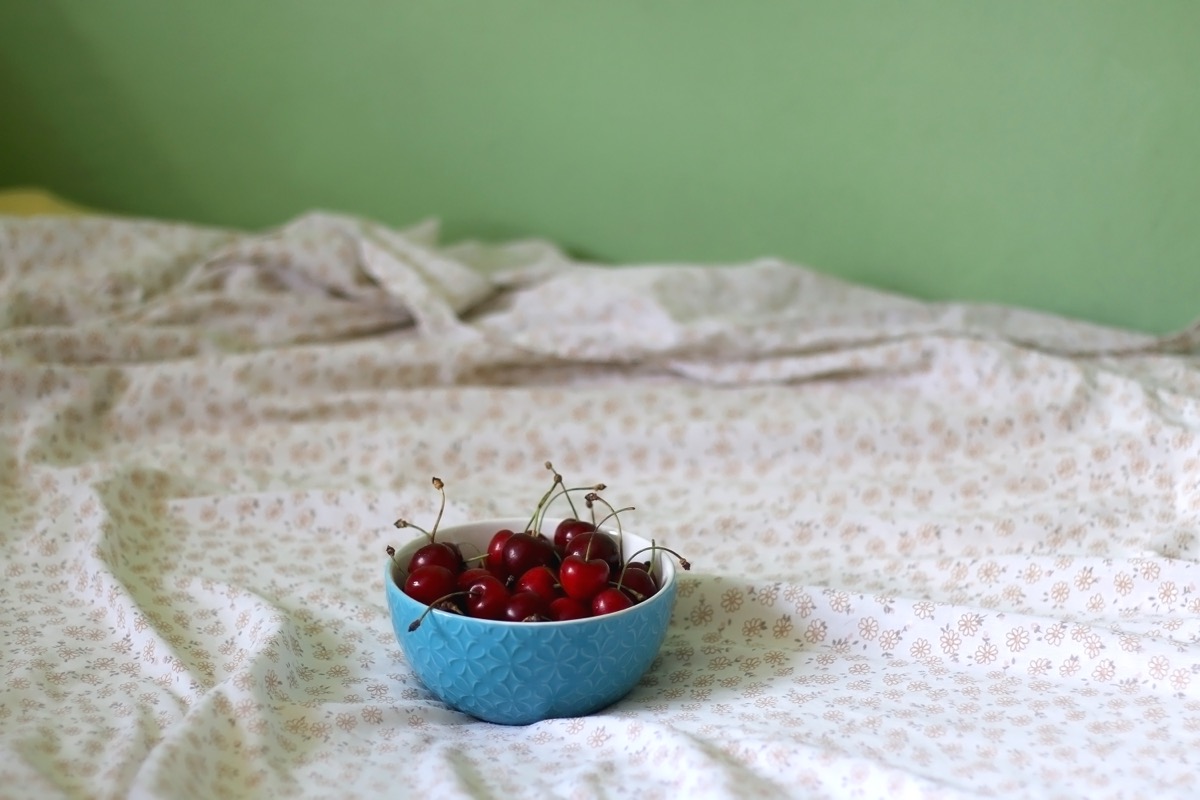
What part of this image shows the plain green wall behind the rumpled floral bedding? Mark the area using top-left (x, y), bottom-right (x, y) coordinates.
top-left (0, 0), bottom-right (1200, 331)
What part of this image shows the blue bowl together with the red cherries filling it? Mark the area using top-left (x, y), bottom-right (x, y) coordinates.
top-left (384, 463), bottom-right (690, 724)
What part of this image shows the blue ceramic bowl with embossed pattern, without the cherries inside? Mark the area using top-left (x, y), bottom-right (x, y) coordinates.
top-left (384, 519), bottom-right (679, 724)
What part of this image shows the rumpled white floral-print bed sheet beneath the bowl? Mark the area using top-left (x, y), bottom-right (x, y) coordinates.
top-left (0, 195), bottom-right (1200, 800)
